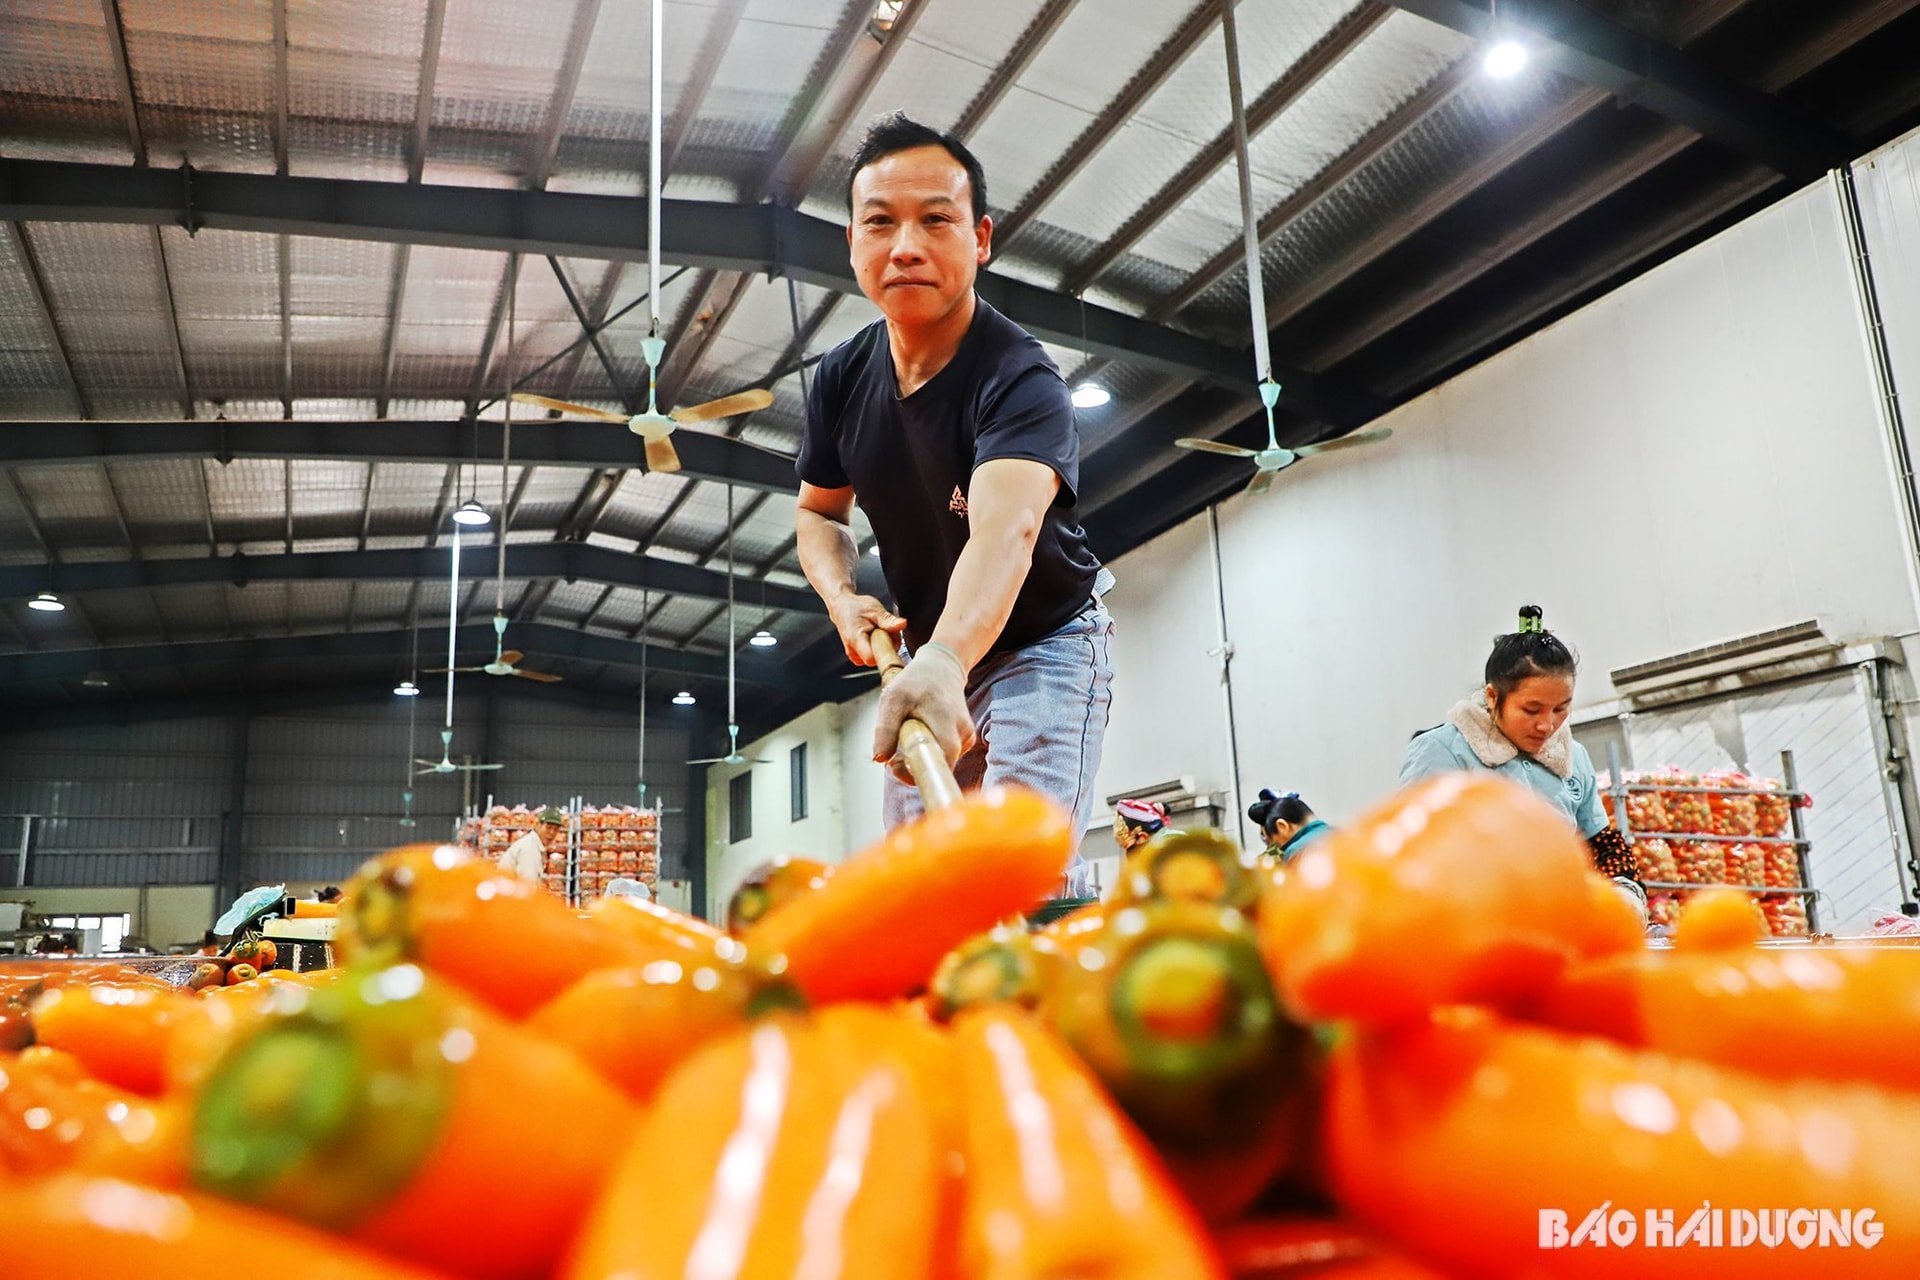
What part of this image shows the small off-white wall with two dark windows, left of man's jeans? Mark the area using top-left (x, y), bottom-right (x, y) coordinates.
top-left (707, 704), bottom-right (847, 919)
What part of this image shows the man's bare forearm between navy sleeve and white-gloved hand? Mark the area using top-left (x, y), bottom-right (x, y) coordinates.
top-left (931, 459), bottom-right (1060, 672)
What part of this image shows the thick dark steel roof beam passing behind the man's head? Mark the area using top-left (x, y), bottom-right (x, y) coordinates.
top-left (0, 159), bottom-right (1297, 402)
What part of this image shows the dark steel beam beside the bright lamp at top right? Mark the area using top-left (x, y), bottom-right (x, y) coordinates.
top-left (1392, 0), bottom-right (1860, 180)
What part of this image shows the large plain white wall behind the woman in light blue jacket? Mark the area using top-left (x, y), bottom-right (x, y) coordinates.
top-left (1100, 169), bottom-right (1914, 836)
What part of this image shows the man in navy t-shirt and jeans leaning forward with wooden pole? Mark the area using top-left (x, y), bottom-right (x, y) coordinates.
top-left (797, 115), bottom-right (1114, 882)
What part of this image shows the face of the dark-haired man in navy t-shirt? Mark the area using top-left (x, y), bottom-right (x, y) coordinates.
top-left (847, 146), bottom-right (993, 328)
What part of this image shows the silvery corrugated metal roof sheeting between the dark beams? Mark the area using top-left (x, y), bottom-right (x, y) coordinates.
top-left (0, 0), bottom-right (1885, 710)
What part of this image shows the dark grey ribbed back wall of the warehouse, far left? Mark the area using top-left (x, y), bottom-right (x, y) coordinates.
top-left (0, 685), bottom-right (693, 901)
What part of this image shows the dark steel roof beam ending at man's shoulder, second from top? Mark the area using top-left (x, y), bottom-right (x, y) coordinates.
top-left (0, 418), bottom-right (801, 493)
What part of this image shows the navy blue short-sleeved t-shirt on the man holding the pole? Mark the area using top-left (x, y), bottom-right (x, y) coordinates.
top-left (795, 297), bottom-right (1100, 652)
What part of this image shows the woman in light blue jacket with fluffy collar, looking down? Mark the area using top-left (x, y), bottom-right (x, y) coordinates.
top-left (1400, 604), bottom-right (1647, 912)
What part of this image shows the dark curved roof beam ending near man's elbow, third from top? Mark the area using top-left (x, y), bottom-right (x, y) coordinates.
top-left (0, 533), bottom-right (826, 616)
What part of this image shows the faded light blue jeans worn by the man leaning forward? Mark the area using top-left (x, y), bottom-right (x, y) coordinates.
top-left (883, 568), bottom-right (1114, 898)
